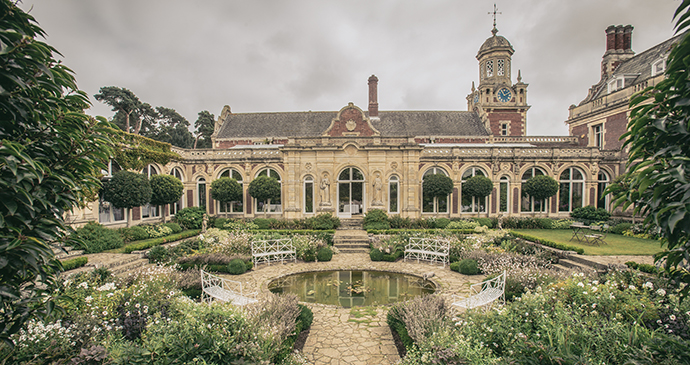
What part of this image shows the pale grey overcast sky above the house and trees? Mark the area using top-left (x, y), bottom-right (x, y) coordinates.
top-left (20, 0), bottom-right (680, 135)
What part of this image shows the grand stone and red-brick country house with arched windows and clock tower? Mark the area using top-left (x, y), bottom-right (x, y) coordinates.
top-left (72, 26), bottom-right (679, 225)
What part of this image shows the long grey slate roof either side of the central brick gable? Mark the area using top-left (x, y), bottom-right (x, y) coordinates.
top-left (217, 111), bottom-right (489, 139)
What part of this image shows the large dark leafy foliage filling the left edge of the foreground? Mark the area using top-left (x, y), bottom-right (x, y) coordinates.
top-left (0, 0), bottom-right (111, 342)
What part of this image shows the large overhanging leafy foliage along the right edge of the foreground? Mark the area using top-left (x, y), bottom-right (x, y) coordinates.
top-left (616, 0), bottom-right (690, 297)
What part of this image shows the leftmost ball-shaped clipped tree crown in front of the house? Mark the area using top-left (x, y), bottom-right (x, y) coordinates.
top-left (103, 170), bottom-right (151, 209)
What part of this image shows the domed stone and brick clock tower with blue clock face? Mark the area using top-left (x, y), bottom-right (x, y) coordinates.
top-left (467, 20), bottom-right (529, 136)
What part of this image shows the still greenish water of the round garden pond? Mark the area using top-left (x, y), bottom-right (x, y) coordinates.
top-left (268, 271), bottom-right (436, 308)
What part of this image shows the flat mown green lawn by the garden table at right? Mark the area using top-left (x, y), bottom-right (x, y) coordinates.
top-left (514, 229), bottom-right (661, 255)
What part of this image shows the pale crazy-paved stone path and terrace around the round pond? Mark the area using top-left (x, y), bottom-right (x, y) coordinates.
top-left (220, 253), bottom-right (484, 365)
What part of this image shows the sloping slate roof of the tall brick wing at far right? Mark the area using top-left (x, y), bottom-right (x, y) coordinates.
top-left (580, 34), bottom-right (685, 105)
